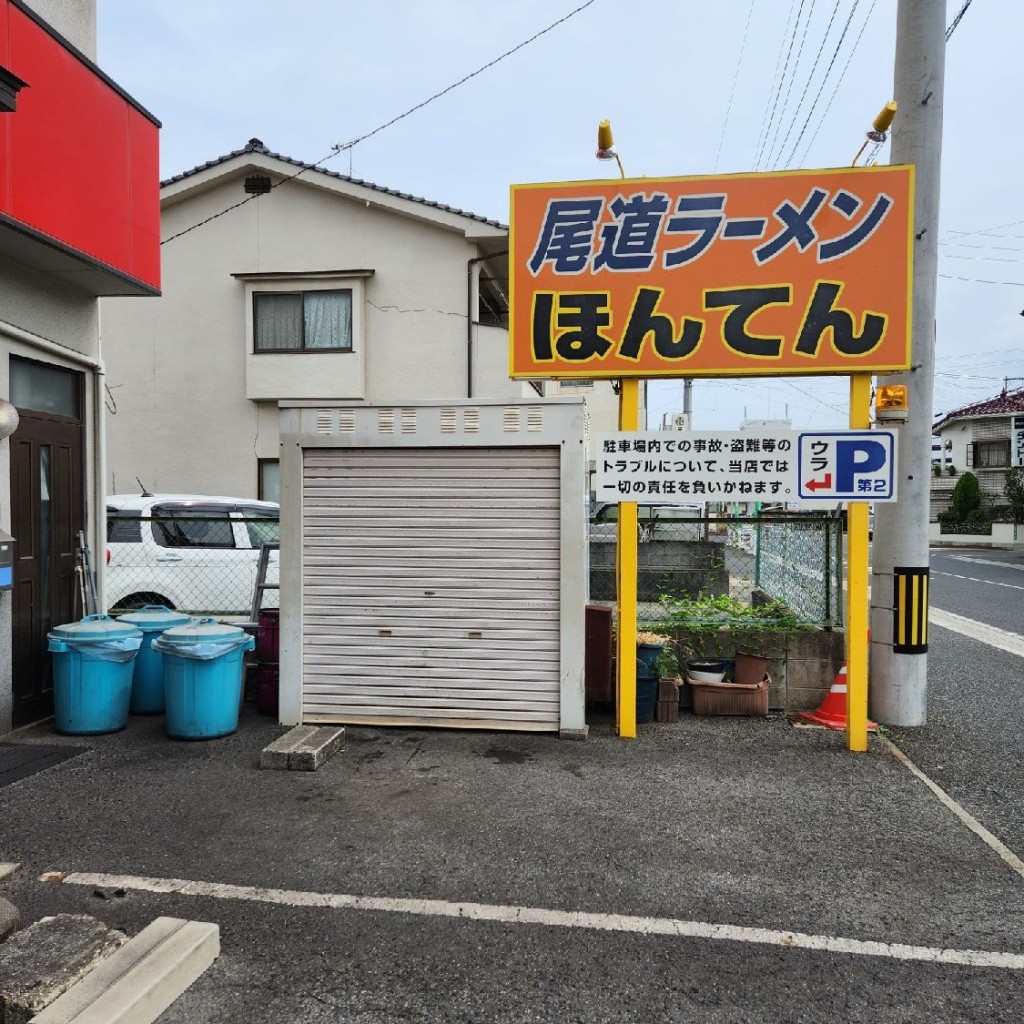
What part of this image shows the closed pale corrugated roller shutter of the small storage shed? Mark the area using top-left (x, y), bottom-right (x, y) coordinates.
top-left (302, 447), bottom-right (560, 730)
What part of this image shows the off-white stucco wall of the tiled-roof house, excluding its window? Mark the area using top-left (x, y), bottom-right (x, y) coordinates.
top-left (102, 170), bottom-right (523, 497)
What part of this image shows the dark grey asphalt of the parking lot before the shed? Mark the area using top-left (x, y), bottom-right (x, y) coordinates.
top-left (0, 692), bottom-right (1024, 1024)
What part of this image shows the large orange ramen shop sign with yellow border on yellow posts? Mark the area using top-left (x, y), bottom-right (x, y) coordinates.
top-left (510, 166), bottom-right (913, 378)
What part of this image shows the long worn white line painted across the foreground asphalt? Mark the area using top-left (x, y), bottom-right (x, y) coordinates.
top-left (51, 871), bottom-right (1024, 971)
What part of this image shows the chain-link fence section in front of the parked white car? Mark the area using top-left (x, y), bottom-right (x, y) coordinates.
top-left (105, 510), bottom-right (280, 618)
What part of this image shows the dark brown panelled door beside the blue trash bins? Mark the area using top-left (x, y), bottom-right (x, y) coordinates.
top-left (10, 410), bottom-right (85, 726)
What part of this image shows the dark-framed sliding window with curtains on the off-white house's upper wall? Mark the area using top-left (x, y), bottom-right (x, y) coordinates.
top-left (253, 289), bottom-right (352, 352)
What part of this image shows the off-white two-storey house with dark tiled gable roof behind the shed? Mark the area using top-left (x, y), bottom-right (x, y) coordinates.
top-left (102, 139), bottom-right (614, 500)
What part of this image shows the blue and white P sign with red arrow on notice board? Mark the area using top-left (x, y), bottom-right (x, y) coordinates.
top-left (797, 430), bottom-right (896, 502)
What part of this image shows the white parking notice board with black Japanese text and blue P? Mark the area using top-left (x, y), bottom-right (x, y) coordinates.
top-left (594, 430), bottom-right (896, 505)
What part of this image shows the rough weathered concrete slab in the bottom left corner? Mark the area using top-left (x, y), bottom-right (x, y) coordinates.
top-left (0, 913), bottom-right (127, 1024)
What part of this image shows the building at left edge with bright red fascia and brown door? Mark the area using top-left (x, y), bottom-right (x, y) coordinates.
top-left (0, 0), bottom-right (160, 734)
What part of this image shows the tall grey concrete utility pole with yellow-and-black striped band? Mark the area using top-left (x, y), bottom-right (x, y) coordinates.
top-left (870, 0), bottom-right (946, 726)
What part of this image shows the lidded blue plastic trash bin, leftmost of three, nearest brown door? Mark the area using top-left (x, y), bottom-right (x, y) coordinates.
top-left (47, 615), bottom-right (142, 736)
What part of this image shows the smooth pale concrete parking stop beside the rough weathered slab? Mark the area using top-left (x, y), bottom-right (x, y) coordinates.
top-left (32, 918), bottom-right (220, 1024)
